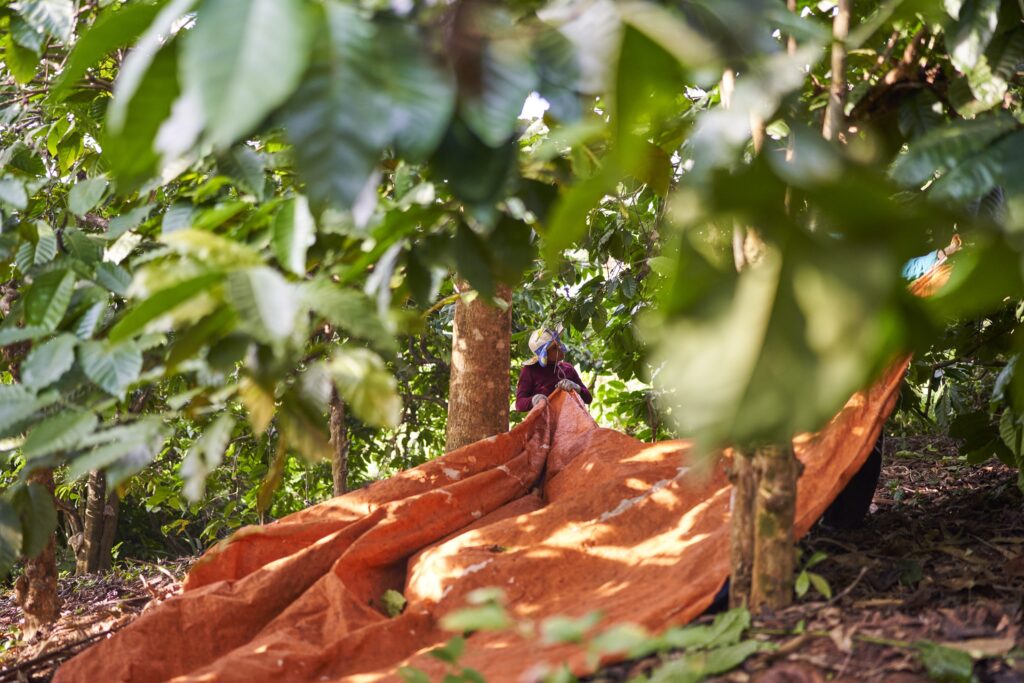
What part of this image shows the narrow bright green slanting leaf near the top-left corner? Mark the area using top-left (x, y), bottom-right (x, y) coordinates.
top-left (49, 0), bottom-right (166, 101)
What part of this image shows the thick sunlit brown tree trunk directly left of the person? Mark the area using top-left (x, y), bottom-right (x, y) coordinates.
top-left (445, 280), bottom-right (512, 452)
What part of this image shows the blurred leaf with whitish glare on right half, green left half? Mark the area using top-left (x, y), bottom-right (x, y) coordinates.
top-left (226, 266), bottom-right (299, 342)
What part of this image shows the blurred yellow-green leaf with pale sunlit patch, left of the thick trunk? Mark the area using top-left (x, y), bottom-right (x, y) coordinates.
top-left (328, 348), bottom-right (401, 428)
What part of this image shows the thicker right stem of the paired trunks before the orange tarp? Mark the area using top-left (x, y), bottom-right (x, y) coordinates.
top-left (751, 444), bottom-right (800, 611)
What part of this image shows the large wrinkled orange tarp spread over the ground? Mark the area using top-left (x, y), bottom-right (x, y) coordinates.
top-left (54, 266), bottom-right (946, 683)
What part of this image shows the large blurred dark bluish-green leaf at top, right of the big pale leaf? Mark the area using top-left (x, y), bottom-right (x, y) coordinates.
top-left (284, 2), bottom-right (454, 207)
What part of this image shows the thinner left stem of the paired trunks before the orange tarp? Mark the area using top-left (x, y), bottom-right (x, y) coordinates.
top-left (729, 449), bottom-right (757, 607)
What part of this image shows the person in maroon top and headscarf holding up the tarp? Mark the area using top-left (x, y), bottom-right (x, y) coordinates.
top-left (515, 326), bottom-right (594, 412)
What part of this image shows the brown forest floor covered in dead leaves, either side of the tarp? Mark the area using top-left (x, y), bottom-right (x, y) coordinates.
top-left (0, 438), bottom-right (1024, 683)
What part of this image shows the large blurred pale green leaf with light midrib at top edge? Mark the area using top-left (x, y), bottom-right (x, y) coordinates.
top-left (181, 0), bottom-right (313, 148)
